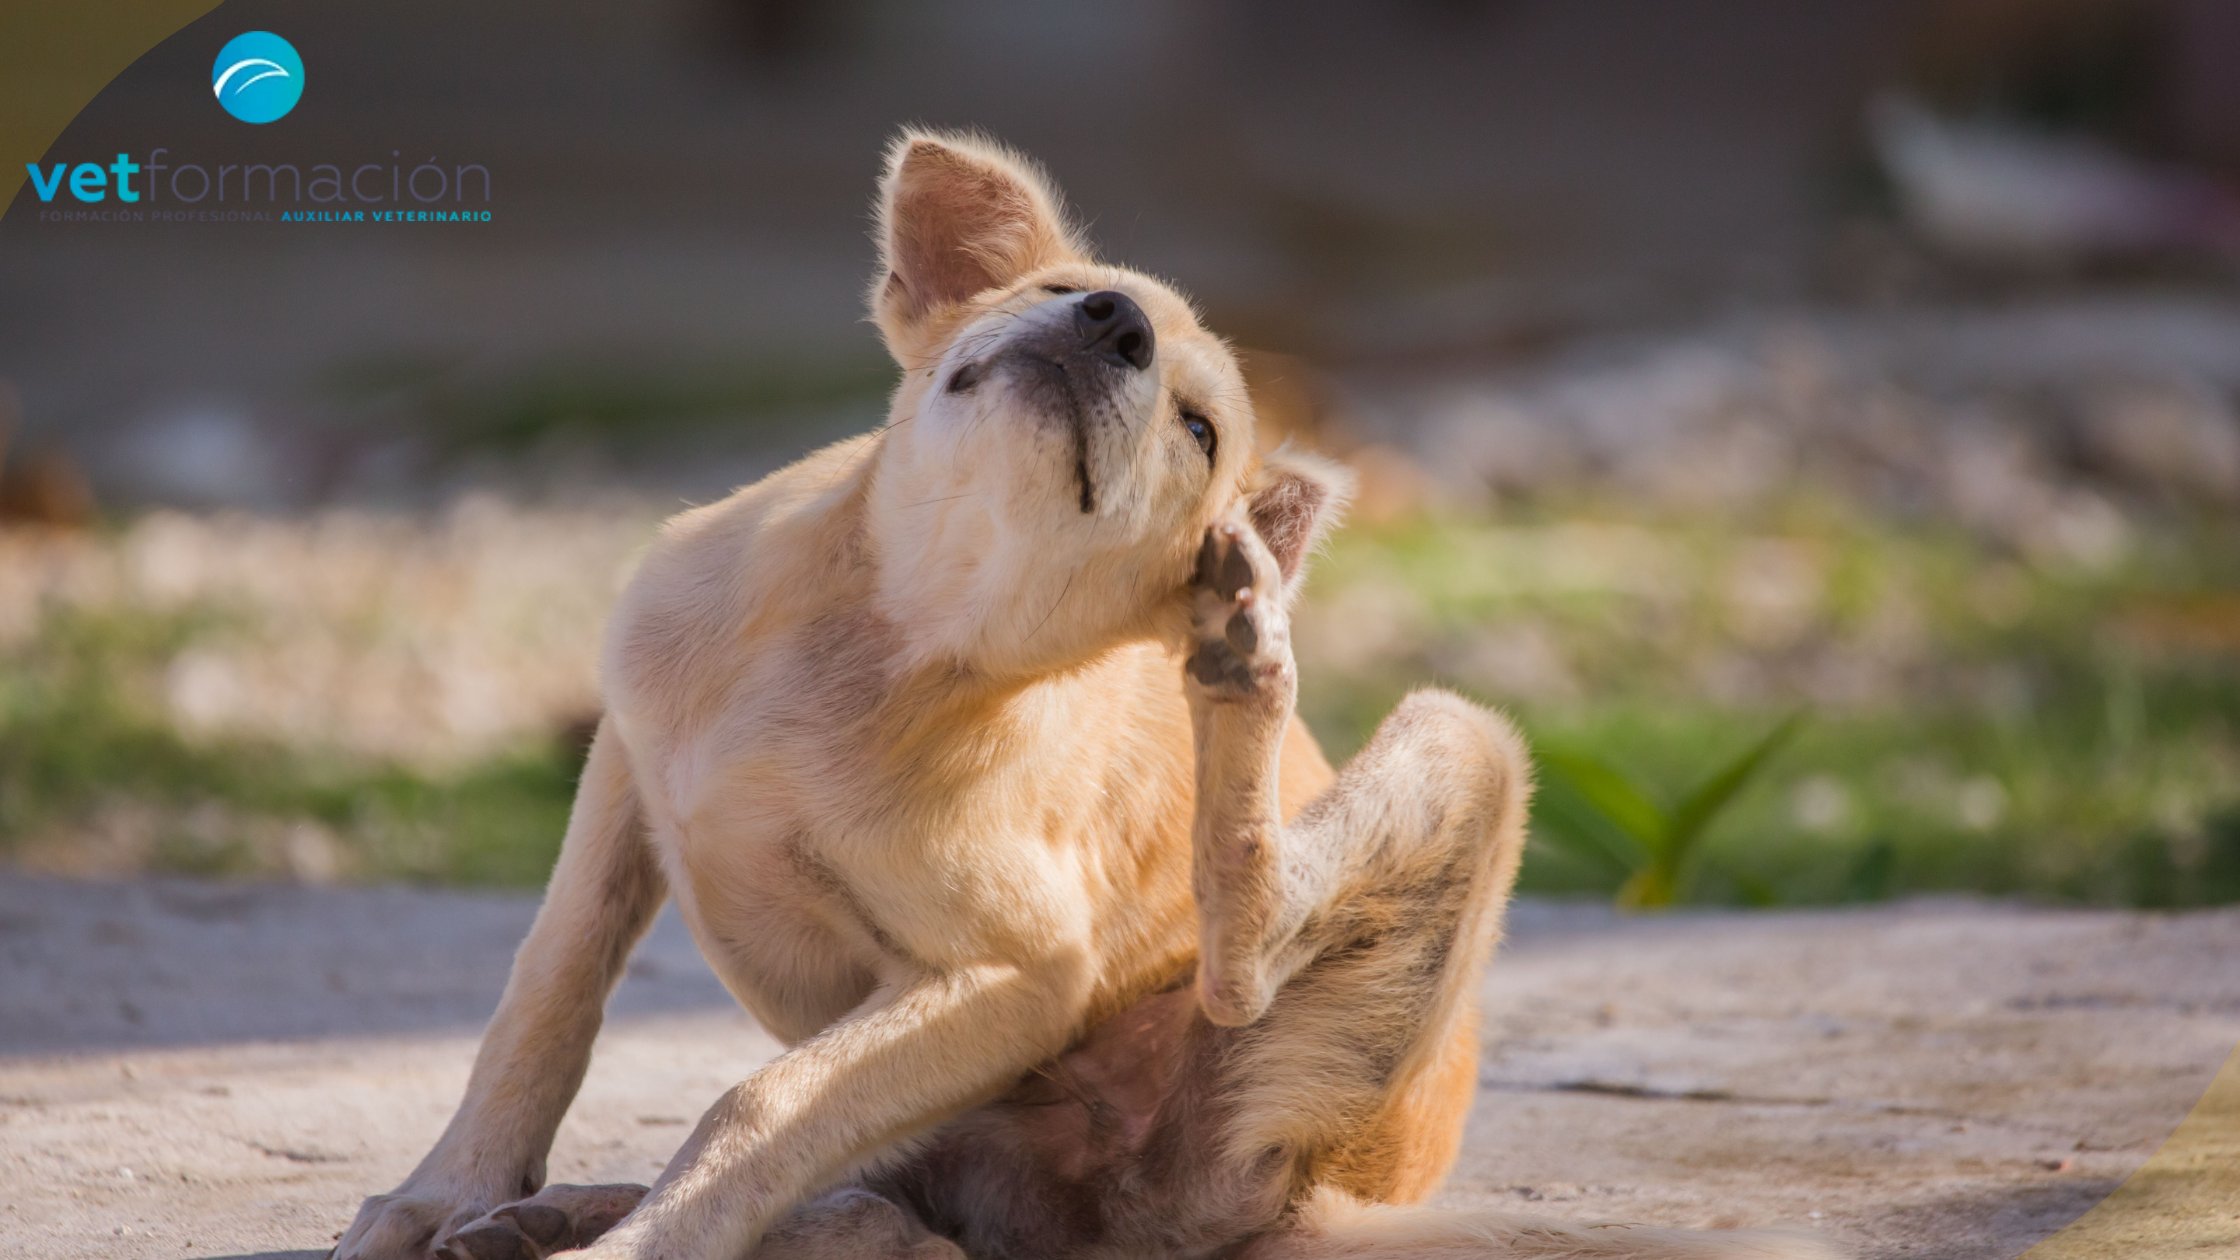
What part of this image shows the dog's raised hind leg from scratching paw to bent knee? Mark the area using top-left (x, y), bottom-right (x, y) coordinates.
top-left (1185, 515), bottom-right (1530, 1062)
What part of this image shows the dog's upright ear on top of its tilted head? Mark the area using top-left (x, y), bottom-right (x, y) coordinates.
top-left (871, 130), bottom-right (1082, 368)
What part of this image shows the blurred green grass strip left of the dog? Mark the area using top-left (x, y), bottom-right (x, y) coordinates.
top-left (0, 608), bottom-right (580, 886)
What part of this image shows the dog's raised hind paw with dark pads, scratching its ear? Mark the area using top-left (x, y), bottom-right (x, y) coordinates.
top-left (1185, 522), bottom-right (1290, 700)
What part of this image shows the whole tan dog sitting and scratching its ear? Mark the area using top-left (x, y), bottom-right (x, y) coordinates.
top-left (336, 132), bottom-right (1823, 1260)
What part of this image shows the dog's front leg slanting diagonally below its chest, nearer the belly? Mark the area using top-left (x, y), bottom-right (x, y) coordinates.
top-left (568, 957), bottom-right (1089, 1260)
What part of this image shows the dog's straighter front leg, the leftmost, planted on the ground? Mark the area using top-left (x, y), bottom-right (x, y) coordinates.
top-left (334, 720), bottom-right (668, 1260)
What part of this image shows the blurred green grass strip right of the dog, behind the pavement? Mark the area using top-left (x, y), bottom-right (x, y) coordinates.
top-left (1301, 502), bottom-right (2240, 906)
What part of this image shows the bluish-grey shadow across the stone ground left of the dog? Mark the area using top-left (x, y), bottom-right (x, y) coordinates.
top-left (0, 877), bottom-right (732, 1056)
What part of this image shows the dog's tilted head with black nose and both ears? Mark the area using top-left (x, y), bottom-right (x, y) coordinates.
top-left (871, 132), bottom-right (1348, 673)
